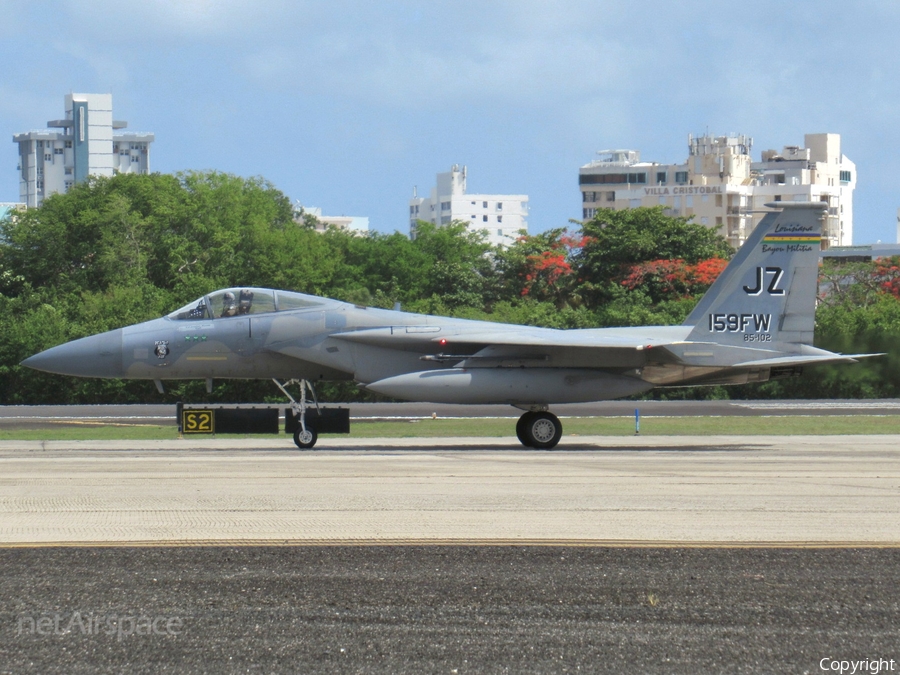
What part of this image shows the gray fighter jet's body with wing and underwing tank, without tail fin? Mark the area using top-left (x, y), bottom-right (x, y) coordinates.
top-left (24, 288), bottom-right (688, 404)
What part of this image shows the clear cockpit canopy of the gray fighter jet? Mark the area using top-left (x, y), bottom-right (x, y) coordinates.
top-left (168, 286), bottom-right (326, 321)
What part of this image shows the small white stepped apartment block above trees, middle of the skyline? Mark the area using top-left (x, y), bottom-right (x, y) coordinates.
top-left (409, 164), bottom-right (528, 246)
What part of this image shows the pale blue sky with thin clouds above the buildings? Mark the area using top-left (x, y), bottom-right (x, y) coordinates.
top-left (0, 0), bottom-right (900, 244)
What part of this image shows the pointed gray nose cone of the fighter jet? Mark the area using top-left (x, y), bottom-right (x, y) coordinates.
top-left (22, 328), bottom-right (124, 377)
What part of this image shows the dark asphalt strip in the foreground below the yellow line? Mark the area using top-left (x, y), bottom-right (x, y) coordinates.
top-left (0, 546), bottom-right (900, 673)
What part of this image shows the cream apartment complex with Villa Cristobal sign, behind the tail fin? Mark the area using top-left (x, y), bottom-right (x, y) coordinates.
top-left (578, 134), bottom-right (856, 248)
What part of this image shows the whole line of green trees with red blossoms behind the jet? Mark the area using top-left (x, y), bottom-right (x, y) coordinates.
top-left (0, 172), bottom-right (900, 404)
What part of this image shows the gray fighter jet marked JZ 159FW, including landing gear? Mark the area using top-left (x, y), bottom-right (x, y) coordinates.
top-left (23, 202), bottom-right (867, 448)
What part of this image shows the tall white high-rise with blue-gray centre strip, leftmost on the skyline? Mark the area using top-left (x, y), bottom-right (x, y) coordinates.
top-left (13, 94), bottom-right (154, 207)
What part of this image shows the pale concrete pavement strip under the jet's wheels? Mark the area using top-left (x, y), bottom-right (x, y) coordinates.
top-left (0, 435), bottom-right (900, 545)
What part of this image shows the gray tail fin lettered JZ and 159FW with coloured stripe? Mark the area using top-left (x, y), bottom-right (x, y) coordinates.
top-left (685, 202), bottom-right (826, 346)
